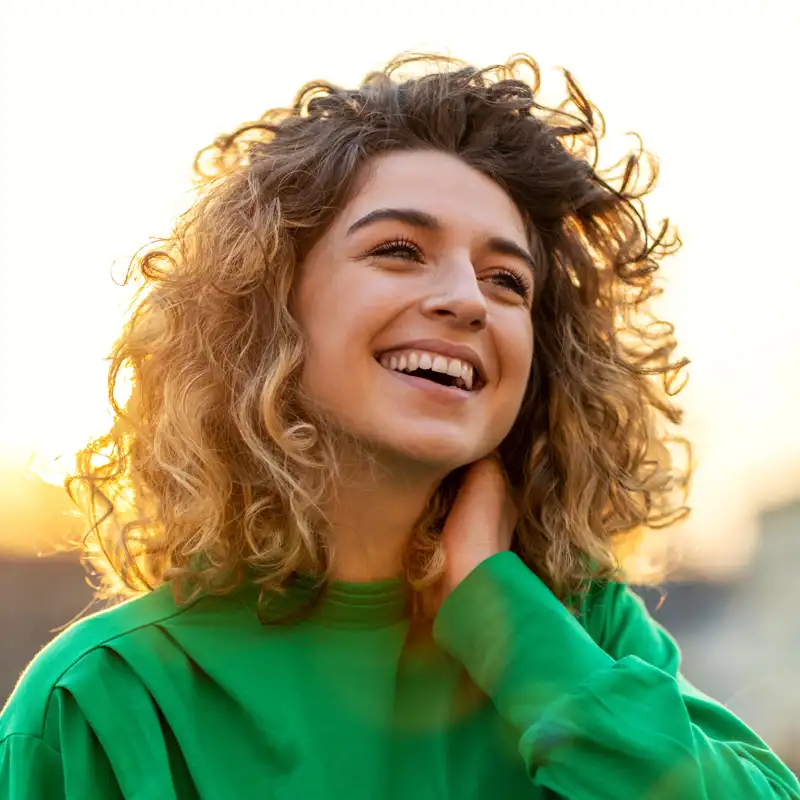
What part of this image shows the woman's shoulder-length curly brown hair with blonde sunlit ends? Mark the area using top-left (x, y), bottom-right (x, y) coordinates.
top-left (65, 54), bottom-right (691, 610)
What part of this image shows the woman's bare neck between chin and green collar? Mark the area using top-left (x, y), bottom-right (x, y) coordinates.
top-left (325, 456), bottom-right (444, 582)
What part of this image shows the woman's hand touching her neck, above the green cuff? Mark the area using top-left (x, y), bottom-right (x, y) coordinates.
top-left (439, 453), bottom-right (517, 604)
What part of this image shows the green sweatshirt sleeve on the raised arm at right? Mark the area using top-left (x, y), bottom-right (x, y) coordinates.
top-left (434, 553), bottom-right (800, 800)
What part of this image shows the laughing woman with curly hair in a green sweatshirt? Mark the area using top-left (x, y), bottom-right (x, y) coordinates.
top-left (0, 57), bottom-right (800, 800)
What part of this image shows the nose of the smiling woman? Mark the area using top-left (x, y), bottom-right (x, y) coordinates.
top-left (422, 258), bottom-right (488, 331)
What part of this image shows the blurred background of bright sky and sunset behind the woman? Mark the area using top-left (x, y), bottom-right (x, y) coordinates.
top-left (0, 0), bottom-right (800, 772)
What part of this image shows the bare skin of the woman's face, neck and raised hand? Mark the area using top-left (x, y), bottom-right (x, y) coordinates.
top-left (292, 151), bottom-right (533, 596)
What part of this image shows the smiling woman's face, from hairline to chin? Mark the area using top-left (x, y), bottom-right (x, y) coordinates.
top-left (293, 151), bottom-right (533, 470)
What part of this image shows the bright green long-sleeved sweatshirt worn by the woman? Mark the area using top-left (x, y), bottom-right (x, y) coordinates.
top-left (0, 553), bottom-right (800, 800)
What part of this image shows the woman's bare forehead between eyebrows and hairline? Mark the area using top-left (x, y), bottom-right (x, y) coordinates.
top-left (339, 151), bottom-right (527, 243)
